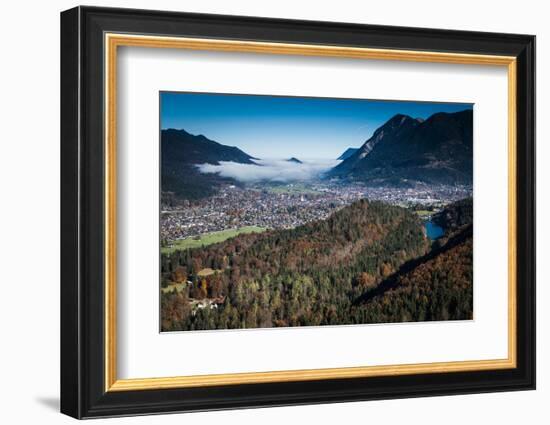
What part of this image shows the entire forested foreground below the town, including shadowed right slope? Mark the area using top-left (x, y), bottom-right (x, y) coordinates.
top-left (161, 200), bottom-right (473, 331)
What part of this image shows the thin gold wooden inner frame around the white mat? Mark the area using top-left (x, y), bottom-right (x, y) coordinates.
top-left (104, 33), bottom-right (517, 391)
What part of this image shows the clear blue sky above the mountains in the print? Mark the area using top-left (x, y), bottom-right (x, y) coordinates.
top-left (160, 92), bottom-right (473, 159)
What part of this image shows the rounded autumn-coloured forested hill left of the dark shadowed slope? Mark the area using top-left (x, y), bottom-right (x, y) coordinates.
top-left (162, 201), bottom-right (429, 330)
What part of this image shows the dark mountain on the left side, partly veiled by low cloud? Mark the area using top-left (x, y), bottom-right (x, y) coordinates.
top-left (161, 129), bottom-right (255, 201)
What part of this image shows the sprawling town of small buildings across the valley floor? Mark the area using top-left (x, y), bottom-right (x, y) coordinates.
top-left (161, 182), bottom-right (472, 241)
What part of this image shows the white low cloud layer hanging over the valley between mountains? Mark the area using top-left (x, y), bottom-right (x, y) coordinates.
top-left (197, 159), bottom-right (340, 183)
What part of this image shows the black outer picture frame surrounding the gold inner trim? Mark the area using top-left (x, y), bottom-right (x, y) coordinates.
top-left (61, 7), bottom-right (535, 418)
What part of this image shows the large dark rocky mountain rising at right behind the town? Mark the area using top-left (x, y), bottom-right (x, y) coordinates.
top-left (328, 110), bottom-right (473, 186)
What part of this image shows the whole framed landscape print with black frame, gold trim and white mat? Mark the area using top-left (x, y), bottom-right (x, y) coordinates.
top-left (61, 7), bottom-right (535, 418)
